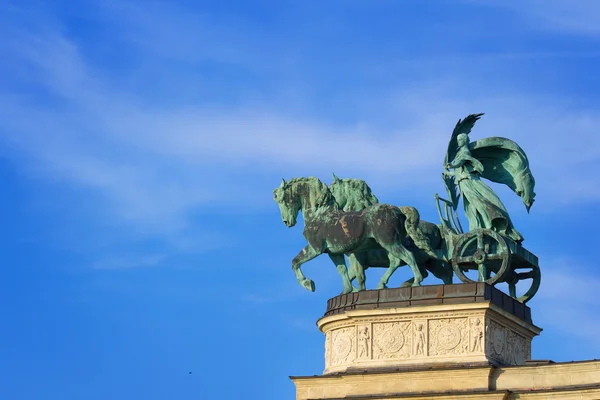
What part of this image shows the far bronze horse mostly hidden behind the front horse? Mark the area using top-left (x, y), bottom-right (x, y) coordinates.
top-left (329, 174), bottom-right (453, 290)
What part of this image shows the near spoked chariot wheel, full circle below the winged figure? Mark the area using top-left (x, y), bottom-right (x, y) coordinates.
top-left (451, 229), bottom-right (511, 285)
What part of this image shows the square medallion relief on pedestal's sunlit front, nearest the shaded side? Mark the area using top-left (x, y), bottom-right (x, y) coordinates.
top-left (429, 318), bottom-right (469, 356)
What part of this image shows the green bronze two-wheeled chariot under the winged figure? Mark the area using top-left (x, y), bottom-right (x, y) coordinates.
top-left (435, 194), bottom-right (541, 303)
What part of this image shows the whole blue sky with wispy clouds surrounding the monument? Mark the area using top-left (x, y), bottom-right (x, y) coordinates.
top-left (0, 0), bottom-right (600, 400)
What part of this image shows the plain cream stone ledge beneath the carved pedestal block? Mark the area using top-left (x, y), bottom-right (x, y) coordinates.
top-left (291, 360), bottom-right (600, 400)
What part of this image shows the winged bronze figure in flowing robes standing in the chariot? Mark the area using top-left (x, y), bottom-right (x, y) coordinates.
top-left (443, 113), bottom-right (535, 243)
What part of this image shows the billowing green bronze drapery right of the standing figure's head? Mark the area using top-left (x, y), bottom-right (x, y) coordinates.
top-left (469, 137), bottom-right (535, 211)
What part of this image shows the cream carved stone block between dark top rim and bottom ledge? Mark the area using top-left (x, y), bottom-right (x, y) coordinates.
top-left (317, 282), bottom-right (541, 374)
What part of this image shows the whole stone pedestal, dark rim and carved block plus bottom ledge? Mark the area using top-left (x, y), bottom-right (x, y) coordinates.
top-left (291, 283), bottom-right (600, 400)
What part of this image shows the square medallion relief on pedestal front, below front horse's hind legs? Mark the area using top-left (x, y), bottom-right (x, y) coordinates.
top-left (373, 321), bottom-right (412, 359)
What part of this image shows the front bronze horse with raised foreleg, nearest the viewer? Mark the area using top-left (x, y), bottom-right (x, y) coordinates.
top-left (273, 177), bottom-right (423, 294)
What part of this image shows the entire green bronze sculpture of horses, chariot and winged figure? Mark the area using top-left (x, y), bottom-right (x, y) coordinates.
top-left (274, 114), bottom-right (541, 302)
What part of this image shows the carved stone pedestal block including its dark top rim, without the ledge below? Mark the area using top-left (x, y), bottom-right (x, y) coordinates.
top-left (317, 283), bottom-right (541, 374)
